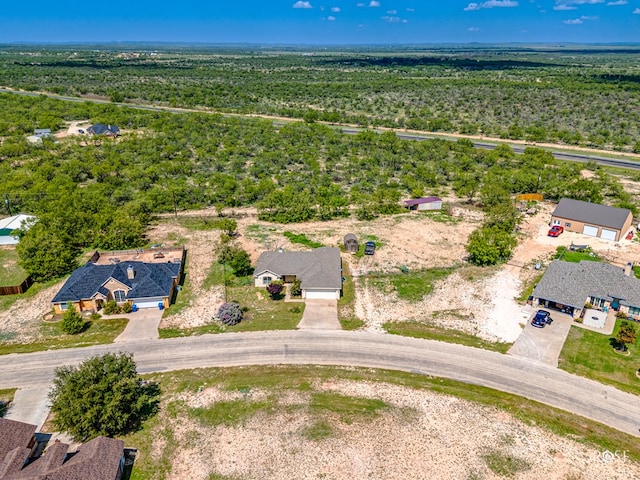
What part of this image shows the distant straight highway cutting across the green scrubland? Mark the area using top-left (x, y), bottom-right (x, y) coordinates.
top-left (0, 88), bottom-right (640, 170)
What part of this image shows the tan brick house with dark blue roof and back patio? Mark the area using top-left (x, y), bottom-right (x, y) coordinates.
top-left (51, 249), bottom-right (184, 314)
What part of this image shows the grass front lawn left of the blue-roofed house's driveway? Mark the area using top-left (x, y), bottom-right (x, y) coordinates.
top-left (0, 318), bottom-right (128, 355)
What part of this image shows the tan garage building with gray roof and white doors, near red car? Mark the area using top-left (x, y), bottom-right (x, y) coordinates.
top-left (551, 198), bottom-right (633, 242)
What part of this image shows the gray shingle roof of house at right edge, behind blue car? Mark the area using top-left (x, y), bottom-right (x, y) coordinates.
top-left (533, 260), bottom-right (640, 308)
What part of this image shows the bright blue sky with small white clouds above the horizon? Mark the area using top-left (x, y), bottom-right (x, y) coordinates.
top-left (0, 0), bottom-right (640, 44)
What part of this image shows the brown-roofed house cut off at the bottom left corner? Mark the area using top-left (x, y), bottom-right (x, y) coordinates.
top-left (0, 418), bottom-right (124, 480)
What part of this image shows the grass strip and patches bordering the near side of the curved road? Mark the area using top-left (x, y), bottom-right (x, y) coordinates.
top-left (123, 366), bottom-right (640, 480)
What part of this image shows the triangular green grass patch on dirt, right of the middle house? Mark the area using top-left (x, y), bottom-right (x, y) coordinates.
top-left (370, 268), bottom-right (455, 302)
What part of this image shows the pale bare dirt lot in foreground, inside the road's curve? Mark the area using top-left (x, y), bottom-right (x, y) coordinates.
top-left (150, 379), bottom-right (640, 480)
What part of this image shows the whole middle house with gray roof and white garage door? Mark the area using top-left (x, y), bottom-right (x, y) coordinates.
top-left (253, 247), bottom-right (342, 300)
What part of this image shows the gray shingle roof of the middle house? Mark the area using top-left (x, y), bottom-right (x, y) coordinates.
top-left (255, 247), bottom-right (342, 290)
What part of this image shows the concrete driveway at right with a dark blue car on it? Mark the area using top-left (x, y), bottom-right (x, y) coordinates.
top-left (507, 309), bottom-right (573, 367)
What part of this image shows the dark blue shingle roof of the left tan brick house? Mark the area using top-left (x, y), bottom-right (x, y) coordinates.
top-left (52, 262), bottom-right (180, 303)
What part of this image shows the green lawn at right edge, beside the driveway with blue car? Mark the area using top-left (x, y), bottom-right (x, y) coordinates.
top-left (558, 320), bottom-right (640, 395)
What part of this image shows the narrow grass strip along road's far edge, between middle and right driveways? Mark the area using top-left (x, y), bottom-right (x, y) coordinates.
top-left (382, 322), bottom-right (513, 353)
